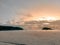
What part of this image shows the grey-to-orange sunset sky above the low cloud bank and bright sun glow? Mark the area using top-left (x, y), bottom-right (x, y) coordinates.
top-left (0, 0), bottom-right (60, 23)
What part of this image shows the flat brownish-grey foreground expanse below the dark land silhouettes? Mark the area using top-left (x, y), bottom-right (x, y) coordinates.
top-left (0, 30), bottom-right (60, 45)
